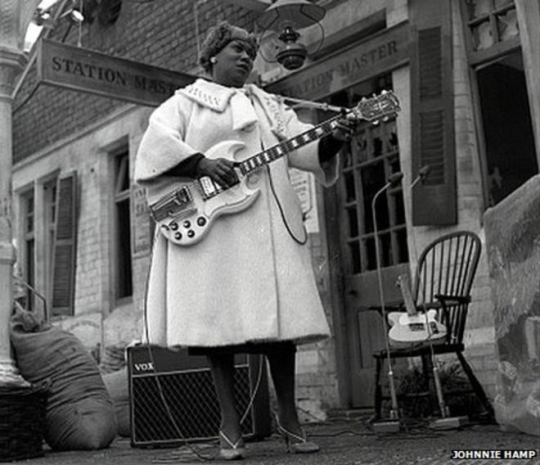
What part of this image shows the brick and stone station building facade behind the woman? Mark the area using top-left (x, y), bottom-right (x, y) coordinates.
top-left (13, 0), bottom-right (540, 418)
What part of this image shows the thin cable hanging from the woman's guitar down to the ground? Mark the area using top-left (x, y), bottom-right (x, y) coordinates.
top-left (139, 228), bottom-right (266, 461)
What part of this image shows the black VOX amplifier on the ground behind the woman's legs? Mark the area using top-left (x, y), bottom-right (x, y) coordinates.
top-left (127, 345), bottom-right (271, 447)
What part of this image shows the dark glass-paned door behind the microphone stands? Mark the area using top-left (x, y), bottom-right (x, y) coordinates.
top-left (328, 75), bottom-right (409, 408)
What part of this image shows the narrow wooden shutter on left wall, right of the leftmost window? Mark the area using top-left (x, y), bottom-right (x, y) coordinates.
top-left (52, 172), bottom-right (77, 315)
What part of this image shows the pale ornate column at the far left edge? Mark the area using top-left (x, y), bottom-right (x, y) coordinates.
top-left (0, 0), bottom-right (39, 386)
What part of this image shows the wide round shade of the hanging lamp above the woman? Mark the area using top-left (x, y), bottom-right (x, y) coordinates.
top-left (257, 0), bottom-right (326, 32)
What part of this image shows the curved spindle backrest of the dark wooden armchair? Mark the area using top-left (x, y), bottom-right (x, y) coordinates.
top-left (413, 231), bottom-right (482, 343)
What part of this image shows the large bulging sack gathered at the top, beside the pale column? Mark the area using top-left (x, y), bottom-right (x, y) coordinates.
top-left (10, 308), bottom-right (117, 450)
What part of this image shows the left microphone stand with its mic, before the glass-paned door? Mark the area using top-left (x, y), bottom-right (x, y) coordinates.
top-left (371, 172), bottom-right (403, 433)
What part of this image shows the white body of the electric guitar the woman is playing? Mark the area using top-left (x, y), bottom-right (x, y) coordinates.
top-left (147, 141), bottom-right (260, 246)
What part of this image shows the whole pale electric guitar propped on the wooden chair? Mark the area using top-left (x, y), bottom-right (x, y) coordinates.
top-left (388, 275), bottom-right (447, 345)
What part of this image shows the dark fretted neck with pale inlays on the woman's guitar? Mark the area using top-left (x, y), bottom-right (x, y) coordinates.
top-left (239, 115), bottom-right (341, 175)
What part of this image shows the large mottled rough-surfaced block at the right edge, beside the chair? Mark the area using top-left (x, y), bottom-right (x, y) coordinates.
top-left (484, 175), bottom-right (540, 436)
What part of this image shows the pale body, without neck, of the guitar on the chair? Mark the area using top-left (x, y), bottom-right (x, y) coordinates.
top-left (388, 310), bottom-right (446, 344)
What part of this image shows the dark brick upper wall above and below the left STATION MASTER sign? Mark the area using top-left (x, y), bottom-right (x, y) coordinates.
top-left (13, 0), bottom-right (253, 163)
